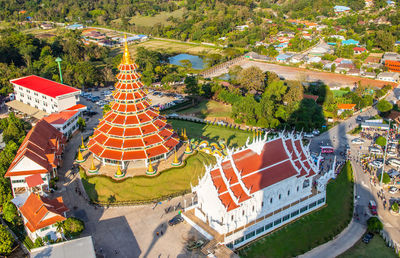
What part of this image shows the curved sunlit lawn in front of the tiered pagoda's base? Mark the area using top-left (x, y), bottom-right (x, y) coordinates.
top-left (82, 152), bottom-right (215, 203)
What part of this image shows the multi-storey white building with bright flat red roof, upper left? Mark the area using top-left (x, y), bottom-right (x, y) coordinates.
top-left (10, 75), bottom-right (81, 114)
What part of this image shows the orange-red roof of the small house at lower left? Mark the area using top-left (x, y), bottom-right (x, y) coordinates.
top-left (19, 193), bottom-right (68, 232)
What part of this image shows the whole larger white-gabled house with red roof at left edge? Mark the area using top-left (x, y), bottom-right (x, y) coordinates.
top-left (4, 119), bottom-right (66, 197)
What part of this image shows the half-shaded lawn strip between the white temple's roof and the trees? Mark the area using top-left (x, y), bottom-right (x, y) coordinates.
top-left (169, 119), bottom-right (253, 147)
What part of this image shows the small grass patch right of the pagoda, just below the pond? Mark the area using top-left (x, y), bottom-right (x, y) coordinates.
top-left (177, 100), bottom-right (232, 119)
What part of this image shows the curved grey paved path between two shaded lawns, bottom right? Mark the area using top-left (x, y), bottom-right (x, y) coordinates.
top-left (298, 219), bottom-right (367, 258)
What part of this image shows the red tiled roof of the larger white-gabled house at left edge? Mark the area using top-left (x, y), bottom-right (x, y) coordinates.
top-left (5, 119), bottom-right (66, 177)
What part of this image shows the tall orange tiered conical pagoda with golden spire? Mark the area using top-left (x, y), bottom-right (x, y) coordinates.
top-left (88, 36), bottom-right (179, 169)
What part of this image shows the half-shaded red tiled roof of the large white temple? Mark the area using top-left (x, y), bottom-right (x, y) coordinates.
top-left (210, 138), bottom-right (315, 211)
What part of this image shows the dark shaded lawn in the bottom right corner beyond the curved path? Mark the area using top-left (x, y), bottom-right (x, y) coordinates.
top-left (338, 234), bottom-right (399, 258)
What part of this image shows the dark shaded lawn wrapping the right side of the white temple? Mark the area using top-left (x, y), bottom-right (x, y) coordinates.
top-left (238, 163), bottom-right (353, 257)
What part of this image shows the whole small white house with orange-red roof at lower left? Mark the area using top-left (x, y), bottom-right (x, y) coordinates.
top-left (18, 193), bottom-right (69, 241)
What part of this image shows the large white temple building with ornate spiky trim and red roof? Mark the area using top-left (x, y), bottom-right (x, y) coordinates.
top-left (183, 133), bottom-right (336, 249)
